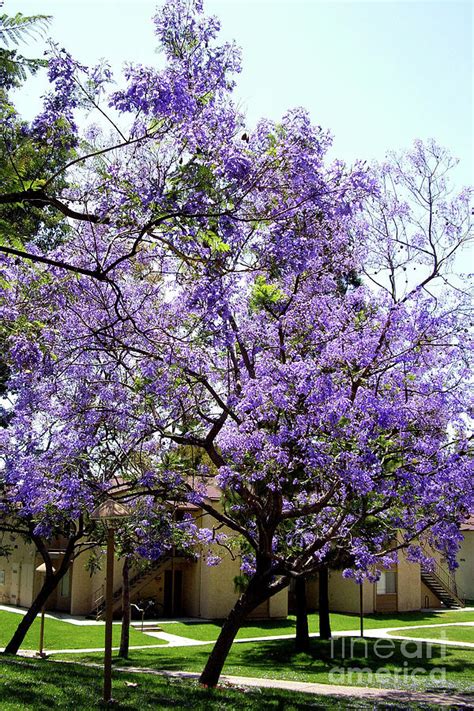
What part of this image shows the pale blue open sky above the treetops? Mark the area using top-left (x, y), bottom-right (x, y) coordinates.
top-left (7, 0), bottom-right (474, 185)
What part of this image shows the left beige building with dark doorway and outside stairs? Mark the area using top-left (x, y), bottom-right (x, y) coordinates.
top-left (0, 538), bottom-right (288, 618)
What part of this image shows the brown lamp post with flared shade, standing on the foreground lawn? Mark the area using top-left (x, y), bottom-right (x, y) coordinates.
top-left (91, 499), bottom-right (129, 704)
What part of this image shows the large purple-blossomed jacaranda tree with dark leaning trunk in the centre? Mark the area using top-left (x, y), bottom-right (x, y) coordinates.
top-left (0, 0), bottom-right (472, 685)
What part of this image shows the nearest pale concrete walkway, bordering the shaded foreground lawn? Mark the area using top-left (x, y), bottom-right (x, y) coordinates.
top-left (57, 662), bottom-right (474, 710)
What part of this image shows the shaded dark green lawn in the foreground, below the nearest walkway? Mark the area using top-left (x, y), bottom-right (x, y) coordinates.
top-left (0, 658), bottom-right (434, 711)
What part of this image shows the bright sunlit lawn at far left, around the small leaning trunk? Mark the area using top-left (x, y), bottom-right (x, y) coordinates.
top-left (0, 610), bottom-right (166, 649)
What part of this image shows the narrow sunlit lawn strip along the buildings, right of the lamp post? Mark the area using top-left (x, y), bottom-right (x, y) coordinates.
top-left (158, 610), bottom-right (474, 641)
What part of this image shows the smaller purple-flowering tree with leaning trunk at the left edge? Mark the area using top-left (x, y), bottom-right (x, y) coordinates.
top-left (0, 308), bottom-right (189, 654)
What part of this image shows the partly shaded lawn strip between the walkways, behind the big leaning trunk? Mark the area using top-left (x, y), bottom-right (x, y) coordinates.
top-left (56, 637), bottom-right (474, 692)
